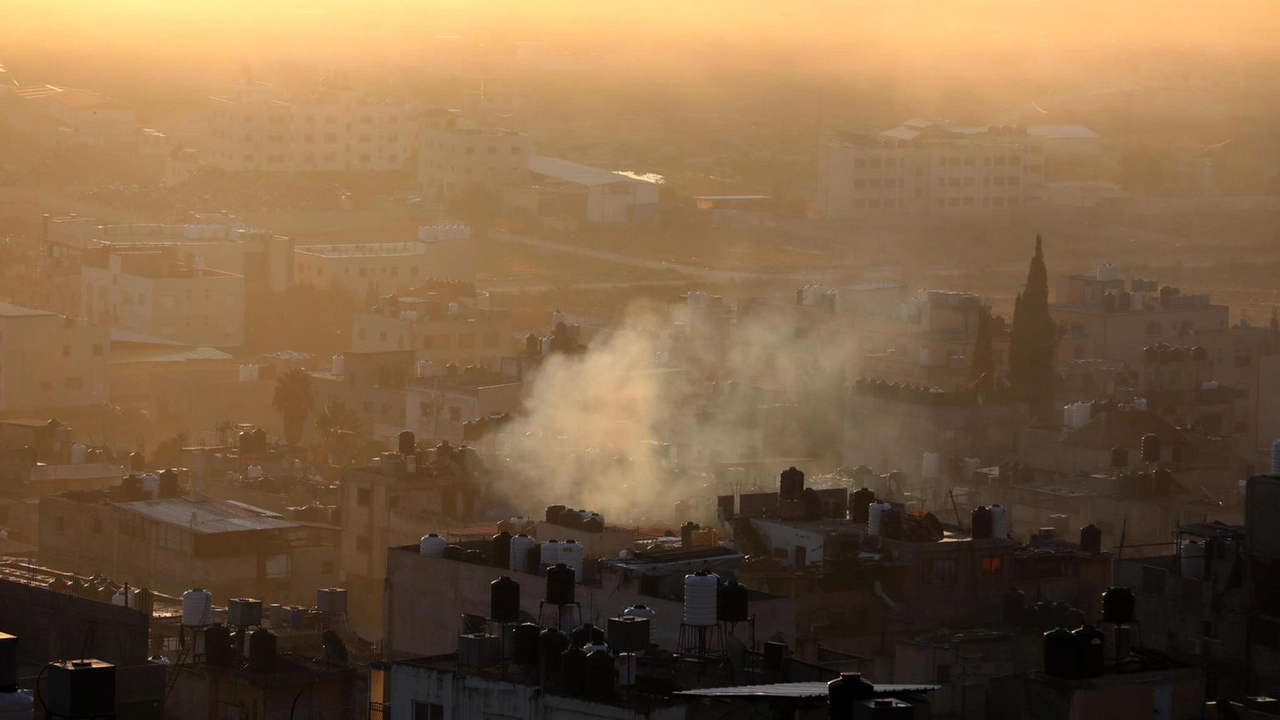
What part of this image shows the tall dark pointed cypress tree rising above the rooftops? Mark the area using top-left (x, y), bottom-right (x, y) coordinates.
top-left (1009, 236), bottom-right (1057, 419)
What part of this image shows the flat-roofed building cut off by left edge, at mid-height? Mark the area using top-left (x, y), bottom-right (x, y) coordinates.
top-left (0, 304), bottom-right (111, 414)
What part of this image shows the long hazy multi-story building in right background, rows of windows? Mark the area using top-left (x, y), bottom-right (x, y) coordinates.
top-left (822, 119), bottom-right (1044, 218)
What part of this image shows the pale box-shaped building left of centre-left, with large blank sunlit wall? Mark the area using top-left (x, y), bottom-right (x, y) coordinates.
top-left (81, 245), bottom-right (244, 347)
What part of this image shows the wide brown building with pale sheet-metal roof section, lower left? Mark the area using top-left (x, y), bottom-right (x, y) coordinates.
top-left (40, 482), bottom-right (339, 605)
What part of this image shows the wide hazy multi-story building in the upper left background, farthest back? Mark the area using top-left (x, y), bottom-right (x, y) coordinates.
top-left (204, 82), bottom-right (415, 172)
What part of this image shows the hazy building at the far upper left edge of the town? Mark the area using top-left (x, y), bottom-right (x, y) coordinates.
top-left (5, 85), bottom-right (138, 148)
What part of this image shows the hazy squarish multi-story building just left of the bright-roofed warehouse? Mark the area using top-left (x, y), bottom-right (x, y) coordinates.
top-left (417, 110), bottom-right (532, 197)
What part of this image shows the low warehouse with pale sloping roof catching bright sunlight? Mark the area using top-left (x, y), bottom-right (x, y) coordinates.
top-left (526, 155), bottom-right (662, 223)
